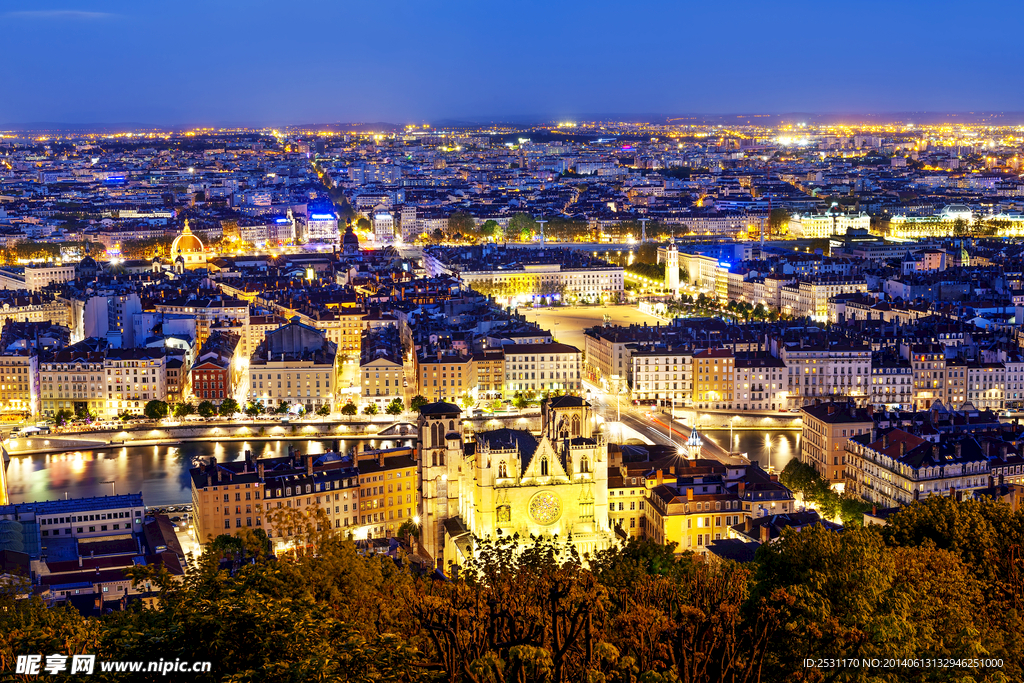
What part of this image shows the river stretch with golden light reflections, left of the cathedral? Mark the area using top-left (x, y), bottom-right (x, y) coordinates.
top-left (7, 439), bottom-right (411, 505)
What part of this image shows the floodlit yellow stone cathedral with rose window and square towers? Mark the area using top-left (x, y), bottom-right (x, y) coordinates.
top-left (419, 396), bottom-right (614, 568)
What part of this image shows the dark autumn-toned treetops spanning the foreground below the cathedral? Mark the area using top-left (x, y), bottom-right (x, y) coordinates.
top-left (0, 499), bottom-right (1024, 683)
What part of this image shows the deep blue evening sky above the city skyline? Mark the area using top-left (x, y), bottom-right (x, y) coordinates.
top-left (0, 0), bottom-right (1024, 125)
